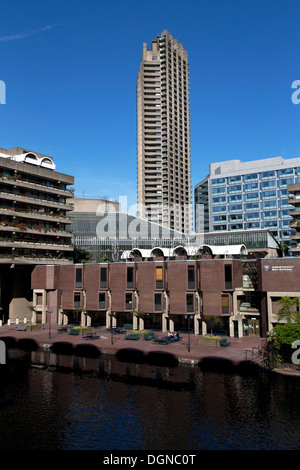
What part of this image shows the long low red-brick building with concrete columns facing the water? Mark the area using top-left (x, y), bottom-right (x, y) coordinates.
top-left (32, 256), bottom-right (300, 337)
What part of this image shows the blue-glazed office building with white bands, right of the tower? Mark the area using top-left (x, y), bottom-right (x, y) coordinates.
top-left (194, 157), bottom-right (300, 245)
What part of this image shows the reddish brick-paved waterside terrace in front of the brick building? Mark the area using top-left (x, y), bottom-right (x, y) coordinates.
top-left (0, 324), bottom-right (265, 367)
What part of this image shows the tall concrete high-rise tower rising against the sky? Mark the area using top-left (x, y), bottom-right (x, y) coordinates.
top-left (137, 31), bottom-right (192, 233)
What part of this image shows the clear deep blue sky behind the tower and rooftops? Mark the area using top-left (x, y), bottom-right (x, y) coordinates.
top-left (0, 0), bottom-right (300, 213)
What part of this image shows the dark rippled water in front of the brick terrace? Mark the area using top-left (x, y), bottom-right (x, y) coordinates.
top-left (0, 349), bottom-right (300, 452)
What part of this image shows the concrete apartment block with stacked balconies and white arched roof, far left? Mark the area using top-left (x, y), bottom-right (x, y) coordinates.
top-left (0, 148), bottom-right (74, 264)
